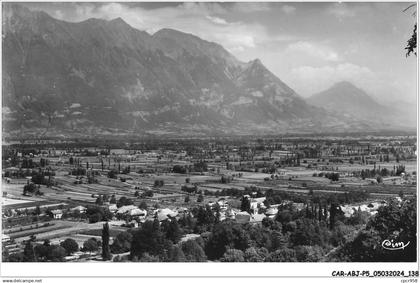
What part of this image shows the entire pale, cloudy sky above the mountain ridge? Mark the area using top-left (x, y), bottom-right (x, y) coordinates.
top-left (18, 2), bottom-right (417, 102)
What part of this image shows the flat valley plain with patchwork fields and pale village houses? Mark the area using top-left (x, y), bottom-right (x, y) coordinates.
top-left (2, 136), bottom-right (417, 261)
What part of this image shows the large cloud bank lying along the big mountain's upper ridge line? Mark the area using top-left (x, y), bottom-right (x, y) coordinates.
top-left (46, 2), bottom-right (278, 60)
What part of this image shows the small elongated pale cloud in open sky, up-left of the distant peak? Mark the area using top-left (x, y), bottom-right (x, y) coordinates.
top-left (287, 41), bottom-right (342, 62)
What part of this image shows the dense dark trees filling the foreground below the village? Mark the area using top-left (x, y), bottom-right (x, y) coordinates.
top-left (3, 198), bottom-right (417, 262)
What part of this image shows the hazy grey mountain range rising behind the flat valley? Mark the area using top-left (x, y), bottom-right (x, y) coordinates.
top-left (2, 4), bottom-right (414, 139)
